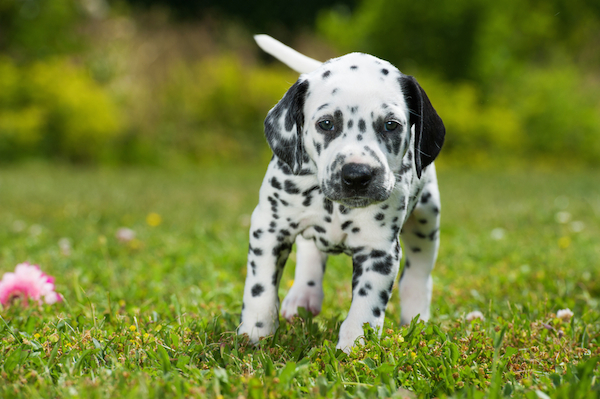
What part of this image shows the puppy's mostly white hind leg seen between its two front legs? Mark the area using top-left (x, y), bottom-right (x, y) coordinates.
top-left (281, 235), bottom-right (327, 320)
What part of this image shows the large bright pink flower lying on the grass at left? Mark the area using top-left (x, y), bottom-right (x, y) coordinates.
top-left (0, 262), bottom-right (62, 306)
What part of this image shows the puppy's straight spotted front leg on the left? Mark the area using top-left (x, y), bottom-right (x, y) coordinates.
top-left (238, 203), bottom-right (295, 342)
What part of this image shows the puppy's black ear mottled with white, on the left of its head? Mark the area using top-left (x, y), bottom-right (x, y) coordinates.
top-left (265, 80), bottom-right (308, 174)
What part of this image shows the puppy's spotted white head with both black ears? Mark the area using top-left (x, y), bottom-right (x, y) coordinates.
top-left (265, 53), bottom-right (445, 207)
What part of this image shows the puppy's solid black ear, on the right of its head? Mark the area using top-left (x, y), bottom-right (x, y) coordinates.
top-left (399, 75), bottom-right (446, 178)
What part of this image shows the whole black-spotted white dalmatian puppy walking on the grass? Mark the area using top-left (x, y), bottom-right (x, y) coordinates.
top-left (238, 35), bottom-right (445, 352)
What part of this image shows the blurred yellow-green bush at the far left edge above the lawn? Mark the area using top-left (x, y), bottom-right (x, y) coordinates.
top-left (0, 57), bottom-right (123, 162)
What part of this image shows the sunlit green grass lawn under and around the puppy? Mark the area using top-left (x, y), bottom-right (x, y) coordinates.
top-left (0, 165), bottom-right (600, 398)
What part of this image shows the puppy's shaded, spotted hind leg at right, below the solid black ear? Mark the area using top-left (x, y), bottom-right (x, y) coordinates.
top-left (400, 173), bottom-right (440, 324)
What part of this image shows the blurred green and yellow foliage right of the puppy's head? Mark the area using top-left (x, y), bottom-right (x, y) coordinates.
top-left (318, 0), bottom-right (600, 165)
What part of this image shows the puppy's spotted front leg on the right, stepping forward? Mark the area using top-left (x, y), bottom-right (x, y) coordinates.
top-left (337, 239), bottom-right (400, 352)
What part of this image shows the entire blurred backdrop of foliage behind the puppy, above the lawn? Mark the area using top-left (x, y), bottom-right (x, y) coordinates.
top-left (0, 0), bottom-right (600, 168)
